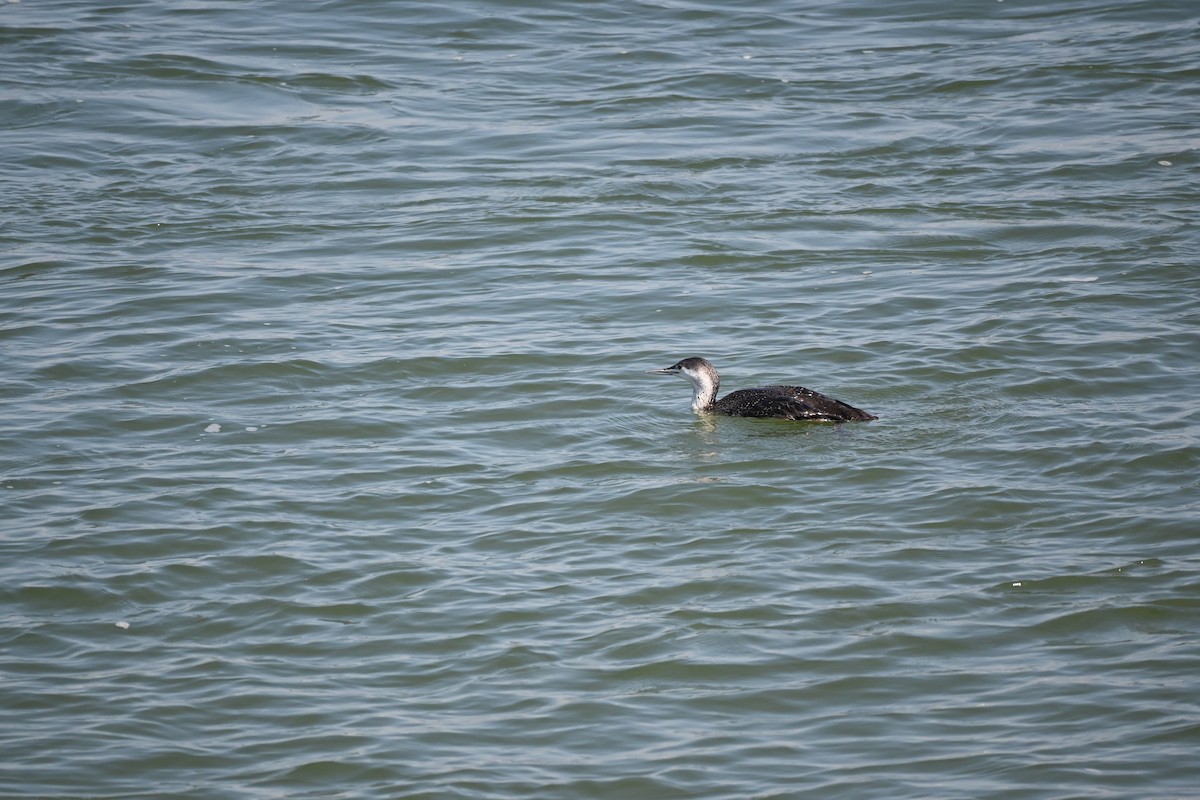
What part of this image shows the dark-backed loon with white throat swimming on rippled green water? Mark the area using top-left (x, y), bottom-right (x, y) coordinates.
top-left (648, 357), bottom-right (878, 422)
